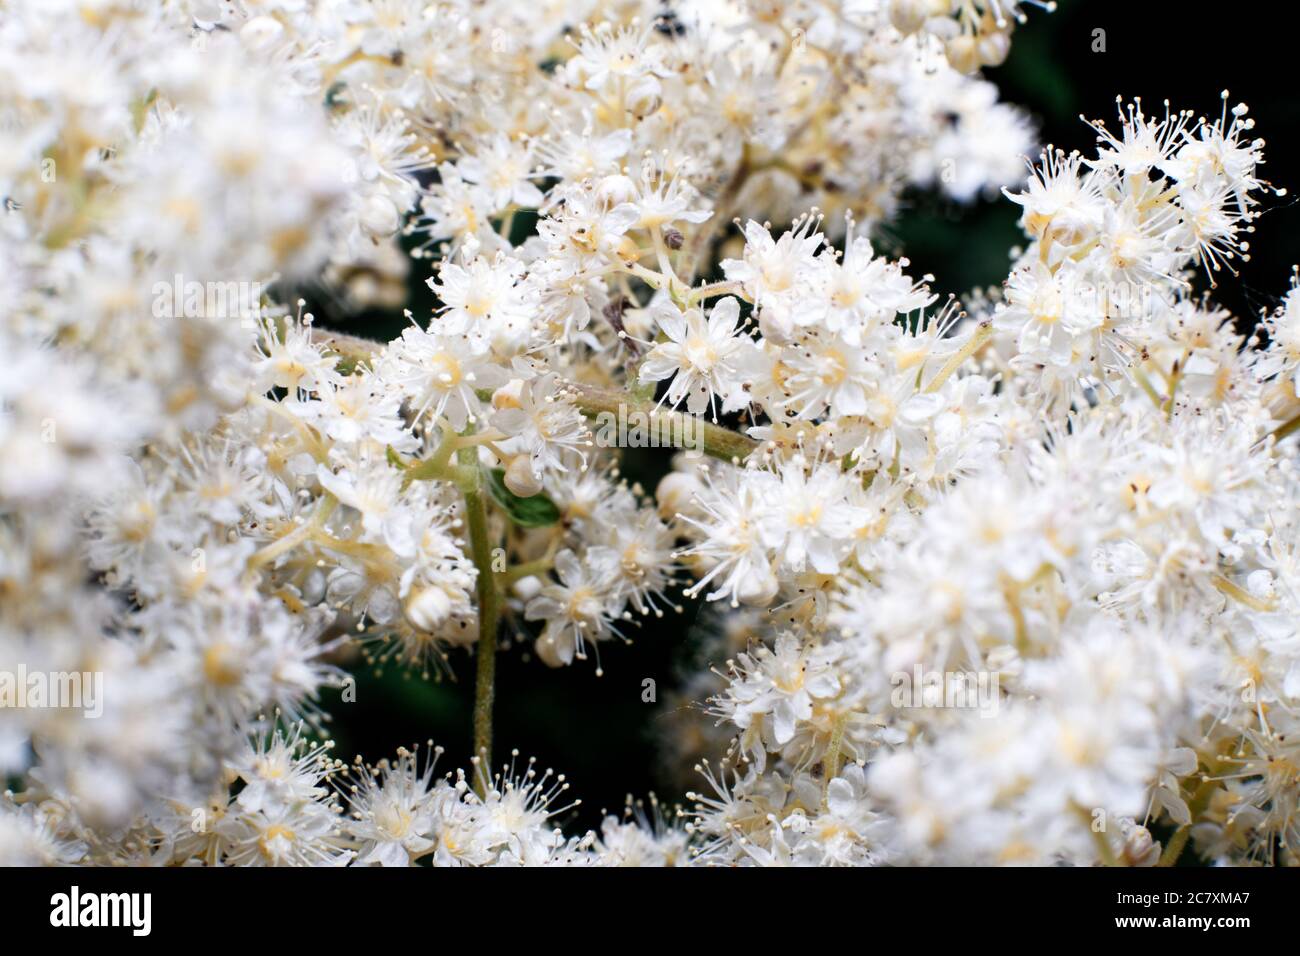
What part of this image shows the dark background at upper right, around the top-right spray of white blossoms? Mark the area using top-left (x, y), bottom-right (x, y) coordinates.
top-left (893, 0), bottom-right (1300, 320)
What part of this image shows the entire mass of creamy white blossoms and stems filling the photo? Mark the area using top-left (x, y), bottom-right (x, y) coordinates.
top-left (0, 0), bottom-right (1300, 866)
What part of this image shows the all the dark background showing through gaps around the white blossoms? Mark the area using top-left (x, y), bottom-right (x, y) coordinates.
top-left (312, 0), bottom-right (1300, 827)
